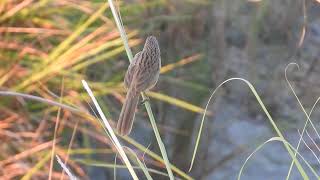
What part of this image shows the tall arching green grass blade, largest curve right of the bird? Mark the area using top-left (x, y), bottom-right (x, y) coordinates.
top-left (189, 78), bottom-right (309, 179)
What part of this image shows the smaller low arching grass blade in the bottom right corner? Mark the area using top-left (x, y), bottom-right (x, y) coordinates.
top-left (238, 137), bottom-right (319, 180)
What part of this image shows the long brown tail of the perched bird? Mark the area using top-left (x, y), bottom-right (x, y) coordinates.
top-left (117, 88), bottom-right (139, 136)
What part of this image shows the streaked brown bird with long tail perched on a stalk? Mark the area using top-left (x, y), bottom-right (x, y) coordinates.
top-left (117, 36), bottom-right (161, 136)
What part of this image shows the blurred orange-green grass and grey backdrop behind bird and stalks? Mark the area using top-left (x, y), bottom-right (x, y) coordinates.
top-left (0, 0), bottom-right (320, 179)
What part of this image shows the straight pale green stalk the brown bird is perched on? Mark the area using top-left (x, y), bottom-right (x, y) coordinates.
top-left (108, 0), bottom-right (174, 180)
